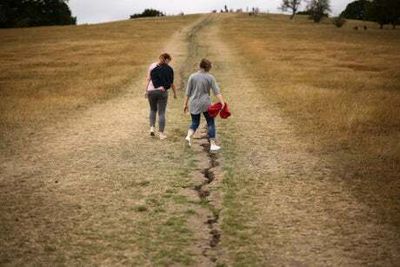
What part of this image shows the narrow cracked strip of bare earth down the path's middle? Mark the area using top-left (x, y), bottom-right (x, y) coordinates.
top-left (176, 15), bottom-right (228, 266)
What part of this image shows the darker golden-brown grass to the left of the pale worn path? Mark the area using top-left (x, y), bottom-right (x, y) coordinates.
top-left (0, 16), bottom-right (200, 147)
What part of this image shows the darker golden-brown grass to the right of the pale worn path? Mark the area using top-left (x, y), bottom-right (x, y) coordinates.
top-left (219, 13), bottom-right (400, 191)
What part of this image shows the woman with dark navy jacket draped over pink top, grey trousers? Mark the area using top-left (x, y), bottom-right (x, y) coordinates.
top-left (145, 53), bottom-right (176, 140)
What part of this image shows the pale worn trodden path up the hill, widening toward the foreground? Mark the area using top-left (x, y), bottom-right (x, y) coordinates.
top-left (0, 15), bottom-right (400, 266)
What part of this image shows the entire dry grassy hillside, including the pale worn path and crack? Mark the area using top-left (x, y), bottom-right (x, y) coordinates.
top-left (0, 14), bottom-right (400, 266)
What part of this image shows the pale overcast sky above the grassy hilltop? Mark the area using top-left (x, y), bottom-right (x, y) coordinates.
top-left (69, 0), bottom-right (352, 24)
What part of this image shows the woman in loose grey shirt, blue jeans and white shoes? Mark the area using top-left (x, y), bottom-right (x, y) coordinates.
top-left (183, 58), bottom-right (225, 152)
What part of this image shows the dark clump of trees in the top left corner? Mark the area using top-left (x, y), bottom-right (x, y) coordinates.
top-left (0, 0), bottom-right (76, 28)
